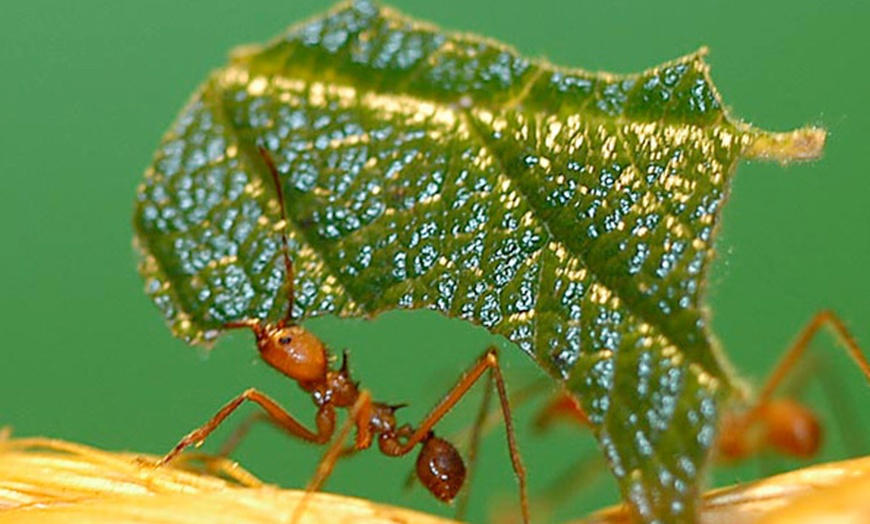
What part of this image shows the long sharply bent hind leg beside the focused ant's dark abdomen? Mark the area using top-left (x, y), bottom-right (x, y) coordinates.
top-left (381, 347), bottom-right (529, 522)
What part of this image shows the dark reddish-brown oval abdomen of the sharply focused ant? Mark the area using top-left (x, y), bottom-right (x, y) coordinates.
top-left (417, 434), bottom-right (465, 502)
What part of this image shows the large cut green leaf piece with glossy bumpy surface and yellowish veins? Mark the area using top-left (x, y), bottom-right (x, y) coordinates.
top-left (134, 1), bottom-right (824, 522)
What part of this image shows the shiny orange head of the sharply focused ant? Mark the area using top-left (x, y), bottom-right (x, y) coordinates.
top-left (257, 323), bottom-right (329, 383)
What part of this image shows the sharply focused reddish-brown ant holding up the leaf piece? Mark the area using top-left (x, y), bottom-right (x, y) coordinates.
top-left (157, 147), bottom-right (529, 523)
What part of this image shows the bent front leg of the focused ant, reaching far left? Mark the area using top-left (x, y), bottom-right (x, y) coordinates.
top-left (157, 388), bottom-right (335, 467)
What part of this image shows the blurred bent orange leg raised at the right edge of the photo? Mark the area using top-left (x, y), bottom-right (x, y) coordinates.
top-left (758, 310), bottom-right (870, 405)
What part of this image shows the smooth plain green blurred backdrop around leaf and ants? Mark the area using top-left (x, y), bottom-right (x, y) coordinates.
top-left (0, 0), bottom-right (870, 521)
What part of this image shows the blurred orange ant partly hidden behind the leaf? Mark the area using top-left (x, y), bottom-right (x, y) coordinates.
top-left (535, 311), bottom-right (870, 462)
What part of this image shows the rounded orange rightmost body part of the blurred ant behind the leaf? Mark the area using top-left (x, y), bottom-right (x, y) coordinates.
top-left (761, 399), bottom-right (822, 458)
